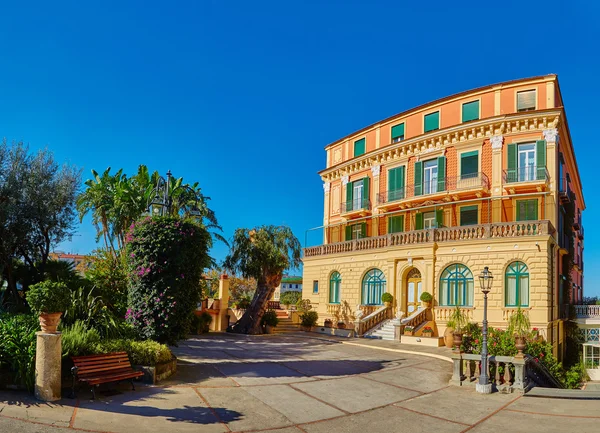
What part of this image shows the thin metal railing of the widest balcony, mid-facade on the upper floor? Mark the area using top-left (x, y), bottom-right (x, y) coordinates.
top-left (377, 172), bottom-right (490, 205)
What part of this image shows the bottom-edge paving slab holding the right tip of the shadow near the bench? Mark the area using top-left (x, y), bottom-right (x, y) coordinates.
top-left (196, 388), bottom-right (293, 431)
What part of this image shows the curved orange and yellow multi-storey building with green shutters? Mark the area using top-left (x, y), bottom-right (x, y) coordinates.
top-left (303, 75), bottom-right (585, 356)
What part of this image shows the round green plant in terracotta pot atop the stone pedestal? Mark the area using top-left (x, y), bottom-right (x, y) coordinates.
top-left (27, 281), bottom-right (71, 333)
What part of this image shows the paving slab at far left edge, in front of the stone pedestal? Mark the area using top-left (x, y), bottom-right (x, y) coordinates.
top-left (0, 391), bottom-right (75, 431)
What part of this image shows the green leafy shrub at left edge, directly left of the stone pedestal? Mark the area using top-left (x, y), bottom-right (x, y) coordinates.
top-left (0, 314), bottom-right (39, 391)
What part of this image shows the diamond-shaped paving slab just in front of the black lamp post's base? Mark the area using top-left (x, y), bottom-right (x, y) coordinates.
top-left (397, 386), bottom-right (518, 424)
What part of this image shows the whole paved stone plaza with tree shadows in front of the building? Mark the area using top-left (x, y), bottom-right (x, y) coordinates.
top-left (0, 334), bottom-right (600, 433)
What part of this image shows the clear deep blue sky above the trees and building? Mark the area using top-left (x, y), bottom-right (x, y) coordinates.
top-left (0, 0), bottom-right (600, 295)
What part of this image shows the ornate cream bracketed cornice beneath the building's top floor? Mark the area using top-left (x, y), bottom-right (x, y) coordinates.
top-left (319, 108), bottom-right (563, 182)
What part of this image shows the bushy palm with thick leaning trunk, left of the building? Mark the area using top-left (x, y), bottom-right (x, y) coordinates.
top-left (224, 225), bottom-right (301, 334)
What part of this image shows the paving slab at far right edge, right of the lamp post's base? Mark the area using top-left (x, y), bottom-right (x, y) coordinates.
top-left (506, 397), bottom-right (600, 418)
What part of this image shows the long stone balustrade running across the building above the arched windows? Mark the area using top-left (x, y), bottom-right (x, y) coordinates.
top-left (304, 220), bottom-right (554, 257)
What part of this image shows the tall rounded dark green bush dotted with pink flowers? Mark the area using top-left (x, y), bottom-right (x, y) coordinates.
top-left (125, 217), bottom-right (211, 344)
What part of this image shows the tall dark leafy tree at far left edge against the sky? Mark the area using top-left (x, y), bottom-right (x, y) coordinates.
top-left (0, 140), bottom-right (80, 303)
